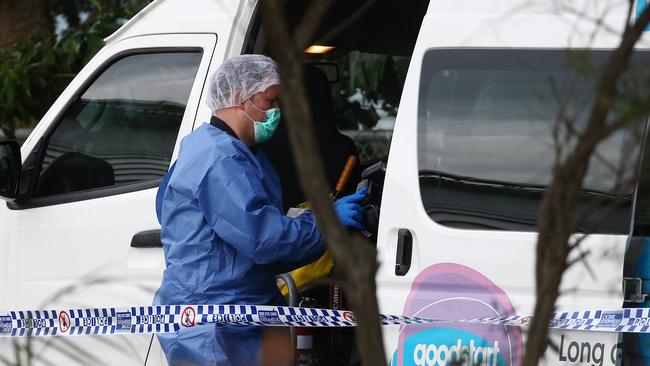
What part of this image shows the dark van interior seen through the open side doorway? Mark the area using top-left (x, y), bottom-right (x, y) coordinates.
top-left (243, 0), bottom-right (429, 209)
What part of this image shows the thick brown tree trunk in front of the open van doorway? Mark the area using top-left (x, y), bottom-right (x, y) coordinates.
top-left (262, 0), bottom-right (386, 366)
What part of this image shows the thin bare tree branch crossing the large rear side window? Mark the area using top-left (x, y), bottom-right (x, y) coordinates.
top-left (523, 2), bottom-right (650, 366)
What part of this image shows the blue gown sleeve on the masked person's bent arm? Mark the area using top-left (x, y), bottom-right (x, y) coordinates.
top-left (197, 155), bottom-right (325, 265)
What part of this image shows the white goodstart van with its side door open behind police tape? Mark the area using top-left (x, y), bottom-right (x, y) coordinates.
top-left (0, 0), bottom-right (650, 365)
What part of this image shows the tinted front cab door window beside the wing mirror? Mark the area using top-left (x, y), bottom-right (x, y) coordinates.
top-left (35, 51), bottom-right (201, 197)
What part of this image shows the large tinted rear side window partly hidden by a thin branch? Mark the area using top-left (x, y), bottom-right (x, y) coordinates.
top-left (418, 49), bottom-right (648, 233)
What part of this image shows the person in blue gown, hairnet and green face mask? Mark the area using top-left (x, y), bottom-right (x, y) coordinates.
top-left (154, 55), bottom-right (366, 365)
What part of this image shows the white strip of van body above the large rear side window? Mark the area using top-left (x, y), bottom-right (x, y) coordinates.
top-left (414, 0), bottom-right (650, 49)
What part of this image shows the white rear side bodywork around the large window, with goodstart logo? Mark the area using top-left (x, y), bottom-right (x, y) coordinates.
top-left (376, 0), bottom-right (649, 365)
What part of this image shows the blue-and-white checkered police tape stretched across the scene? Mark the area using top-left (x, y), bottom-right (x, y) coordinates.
top-left (0, 305), bottom-right (650, 337)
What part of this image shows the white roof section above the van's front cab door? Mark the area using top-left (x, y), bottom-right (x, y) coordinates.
top-left (104, 0), bottom-right (240, 44)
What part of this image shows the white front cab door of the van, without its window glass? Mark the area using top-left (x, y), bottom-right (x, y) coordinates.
top-left (0, 33), bottom-right (218, 365)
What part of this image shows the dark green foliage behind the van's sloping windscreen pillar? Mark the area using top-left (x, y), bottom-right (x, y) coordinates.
top-left (0, 0), bottom-right (150, 139)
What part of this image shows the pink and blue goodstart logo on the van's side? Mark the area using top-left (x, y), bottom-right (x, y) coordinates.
top-left (393, 263), bottom-right (528, 366)
